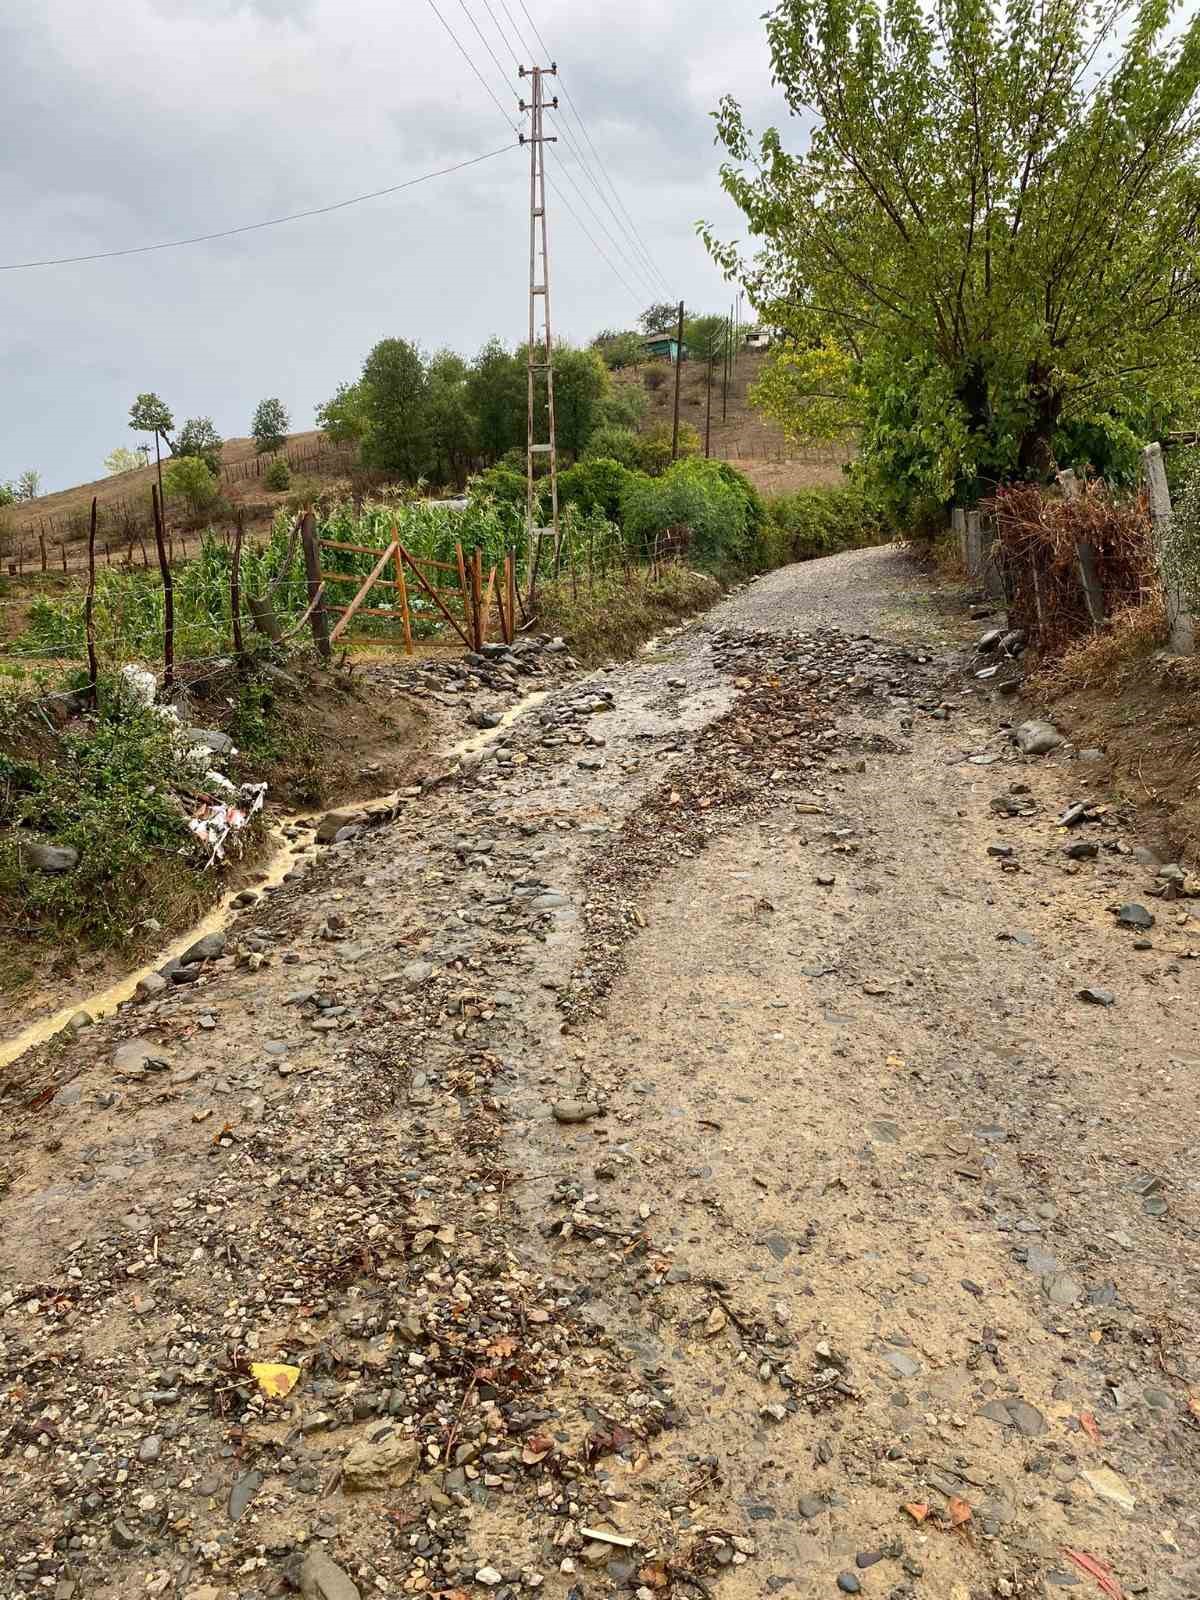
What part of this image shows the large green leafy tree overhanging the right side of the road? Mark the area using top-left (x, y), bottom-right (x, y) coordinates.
top-left (704, 0), bottom-right (1200, 494)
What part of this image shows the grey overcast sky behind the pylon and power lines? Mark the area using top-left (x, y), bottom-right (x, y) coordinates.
top-left (0, 0), bottom-right (779, 491)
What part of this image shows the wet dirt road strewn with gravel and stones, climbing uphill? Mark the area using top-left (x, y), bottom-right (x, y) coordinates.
top-left (0, 550), bottom-right (1200, 1600)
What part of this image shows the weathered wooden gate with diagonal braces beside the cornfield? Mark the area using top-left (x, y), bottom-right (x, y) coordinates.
top-left (317, 528), bottom-right (517, 656)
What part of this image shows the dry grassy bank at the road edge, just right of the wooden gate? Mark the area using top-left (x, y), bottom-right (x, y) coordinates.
top-left (538, 566), bottom-right (722, 667)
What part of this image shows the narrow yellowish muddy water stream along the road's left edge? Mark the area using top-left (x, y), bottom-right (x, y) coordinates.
top-left (0, 690), bottom-right (549, 1067)
